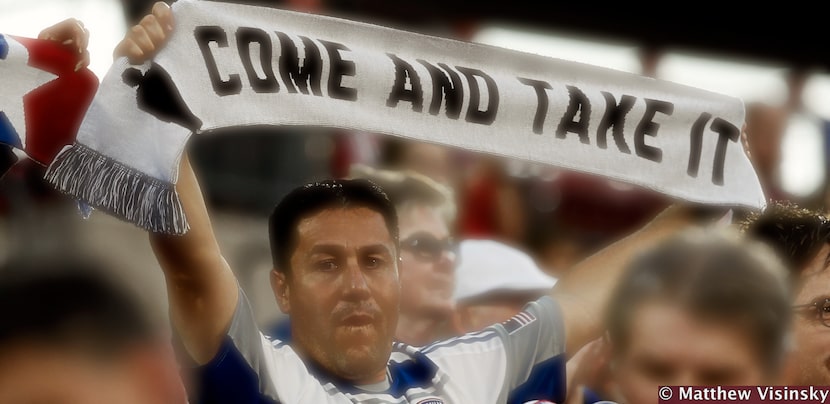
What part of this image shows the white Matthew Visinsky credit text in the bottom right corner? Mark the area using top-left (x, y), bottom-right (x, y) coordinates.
top-left (680, 386), bottom-right (830, 403)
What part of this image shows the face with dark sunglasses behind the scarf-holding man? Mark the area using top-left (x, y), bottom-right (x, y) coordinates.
top-left (400, 206), bottom-right (455, 316)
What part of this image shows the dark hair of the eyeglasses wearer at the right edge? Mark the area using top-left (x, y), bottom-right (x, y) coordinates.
top-left (741, 201), bottom-right (830, 281)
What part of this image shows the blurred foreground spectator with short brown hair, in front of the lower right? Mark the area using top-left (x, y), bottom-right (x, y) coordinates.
top-left (575, 230), bottom-right (791, 404)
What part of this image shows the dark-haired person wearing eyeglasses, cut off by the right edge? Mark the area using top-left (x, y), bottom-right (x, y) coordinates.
top-left (743, 202), bottom-right (830, 386)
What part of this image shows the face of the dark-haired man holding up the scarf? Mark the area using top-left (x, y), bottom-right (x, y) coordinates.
top-left (277, 207), bottom-right (400, 384)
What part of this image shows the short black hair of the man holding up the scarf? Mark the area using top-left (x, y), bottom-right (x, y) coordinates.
top-left (269, 179), bottom-right (399, 273)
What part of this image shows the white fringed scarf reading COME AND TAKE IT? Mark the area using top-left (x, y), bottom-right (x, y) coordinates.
top-left (47, 0), bottom-right (765, 234)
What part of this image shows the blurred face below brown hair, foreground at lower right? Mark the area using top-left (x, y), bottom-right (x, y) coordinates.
top-left (612, 302), bottom-right (766, 404)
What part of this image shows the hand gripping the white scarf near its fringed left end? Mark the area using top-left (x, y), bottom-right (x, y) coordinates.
top-left (113, 1), bottom-right (173, 64)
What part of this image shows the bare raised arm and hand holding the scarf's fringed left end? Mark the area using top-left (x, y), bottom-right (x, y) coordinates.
top-left (113, 2), bottom-right (238, 364)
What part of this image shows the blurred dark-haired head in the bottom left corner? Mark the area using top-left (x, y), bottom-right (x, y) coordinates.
top-left (0, 258), bottom-right (186, 404)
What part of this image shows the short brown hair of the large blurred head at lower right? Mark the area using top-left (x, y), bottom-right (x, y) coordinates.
top-left (606, 231), bottom-right (791, 372)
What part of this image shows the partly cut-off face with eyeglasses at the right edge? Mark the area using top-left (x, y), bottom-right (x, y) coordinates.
top-left (787, 244), bottom-right (830, 386)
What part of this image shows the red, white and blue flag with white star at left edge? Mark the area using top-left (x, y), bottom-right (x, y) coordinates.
top-left (0, 34), bottom-right (98, 176)
